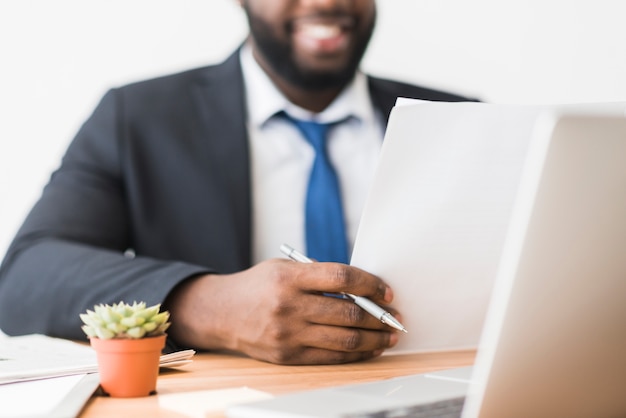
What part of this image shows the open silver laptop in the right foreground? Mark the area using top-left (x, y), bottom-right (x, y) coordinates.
top-left (227, 114), bottom-right (626, 418)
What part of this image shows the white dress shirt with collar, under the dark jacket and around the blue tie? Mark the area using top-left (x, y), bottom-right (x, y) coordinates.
top-left (241, 45), bottom-right (384, 264)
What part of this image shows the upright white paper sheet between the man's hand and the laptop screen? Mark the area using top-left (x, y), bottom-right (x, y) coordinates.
top-left (351, 101), bottom-right (545, 353)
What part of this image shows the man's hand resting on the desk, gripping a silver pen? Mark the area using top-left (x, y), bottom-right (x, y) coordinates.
top-left (165, 259), bottom-right (398, 364)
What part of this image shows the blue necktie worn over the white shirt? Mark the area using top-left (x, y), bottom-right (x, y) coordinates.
top-left (285, 114), bottom-right (348, 264)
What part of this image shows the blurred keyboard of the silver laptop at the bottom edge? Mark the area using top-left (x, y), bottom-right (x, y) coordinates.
top-left (345, 397), bottom-right (465, 418)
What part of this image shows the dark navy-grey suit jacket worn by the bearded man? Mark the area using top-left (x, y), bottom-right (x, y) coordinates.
top-left (0, 49), bottom-right (465, 339)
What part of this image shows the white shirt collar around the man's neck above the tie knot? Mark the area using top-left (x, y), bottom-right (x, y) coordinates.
top-left (240, 43), bottom-right (374, 127)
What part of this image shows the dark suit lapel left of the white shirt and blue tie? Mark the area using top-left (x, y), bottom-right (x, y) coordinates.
top-left (193, 50), bottom-right (251, 270)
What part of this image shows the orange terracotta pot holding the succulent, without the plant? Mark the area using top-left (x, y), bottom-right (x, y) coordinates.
top-left (90, 335), bottom-right (165, 398)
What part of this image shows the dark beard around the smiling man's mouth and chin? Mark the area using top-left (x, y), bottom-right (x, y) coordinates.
top-left (241, 10), bottom-right (375, 91)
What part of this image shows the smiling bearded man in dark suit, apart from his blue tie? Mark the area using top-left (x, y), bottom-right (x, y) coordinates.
top-left (0, 0), bottom-right (464, 364)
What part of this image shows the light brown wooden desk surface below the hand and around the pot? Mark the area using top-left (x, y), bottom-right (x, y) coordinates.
top-left (81, 351), bottom-right (475, 418)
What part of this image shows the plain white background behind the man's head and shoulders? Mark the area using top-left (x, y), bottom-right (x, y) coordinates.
top-left (0, 0), bottom-right (626, 258)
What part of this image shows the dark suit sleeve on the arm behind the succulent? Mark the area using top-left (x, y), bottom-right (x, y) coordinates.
top-left (0, 92), bottom-right (211, 339)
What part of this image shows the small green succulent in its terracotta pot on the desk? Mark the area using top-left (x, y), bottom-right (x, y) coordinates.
top-left (80, 302), bottom-right (170, 398)
